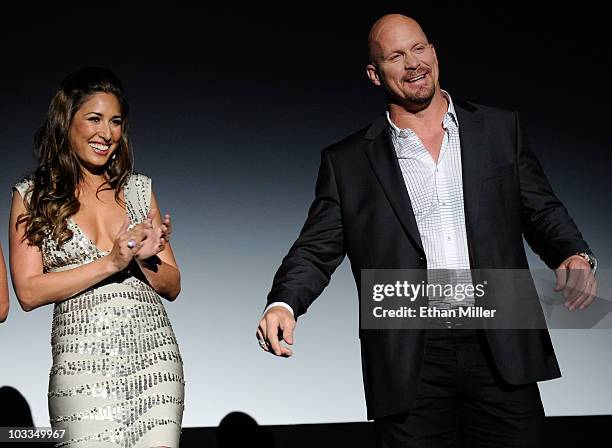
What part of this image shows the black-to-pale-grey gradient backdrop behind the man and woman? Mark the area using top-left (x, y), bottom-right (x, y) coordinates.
top-left (0, 2), bottom-right (612, 426)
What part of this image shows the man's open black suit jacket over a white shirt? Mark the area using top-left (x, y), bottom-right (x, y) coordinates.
top-left (268, 101), bottom-right (590, 419)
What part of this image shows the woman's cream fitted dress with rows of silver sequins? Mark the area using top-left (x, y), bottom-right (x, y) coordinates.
top-left (15, 173), bottom-right (185, 448)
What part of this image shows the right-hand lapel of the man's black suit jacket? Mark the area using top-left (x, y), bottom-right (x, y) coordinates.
top-left (453, 101), bottom-right (486, 235)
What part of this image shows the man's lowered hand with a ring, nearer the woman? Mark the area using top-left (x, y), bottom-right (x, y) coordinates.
top-left (257, 306), bottom-right (295, 358)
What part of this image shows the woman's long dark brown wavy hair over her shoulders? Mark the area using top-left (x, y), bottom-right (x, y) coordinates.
top-left (17, 67), bottom-right (132, 247)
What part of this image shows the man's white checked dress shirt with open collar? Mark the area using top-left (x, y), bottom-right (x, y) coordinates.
top-left (387, 92), bottom-right (473, 308)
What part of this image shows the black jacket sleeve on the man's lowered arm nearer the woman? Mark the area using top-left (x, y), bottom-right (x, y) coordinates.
top-left (268, 150), bottom-right (346, 317)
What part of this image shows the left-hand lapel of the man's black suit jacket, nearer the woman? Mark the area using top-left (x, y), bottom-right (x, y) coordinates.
top-left (364, 116), bottom-right (425, 254)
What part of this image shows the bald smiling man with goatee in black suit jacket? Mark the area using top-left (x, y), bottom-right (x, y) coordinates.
top-left (257, 14), bottom-right (596, 447)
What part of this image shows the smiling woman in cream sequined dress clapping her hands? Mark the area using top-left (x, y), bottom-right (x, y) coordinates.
top-left (10, 67), bottom-right (184, 447)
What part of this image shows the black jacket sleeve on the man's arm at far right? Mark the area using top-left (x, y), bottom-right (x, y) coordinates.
top-left (515, 114), bottom-right (591, 269)
